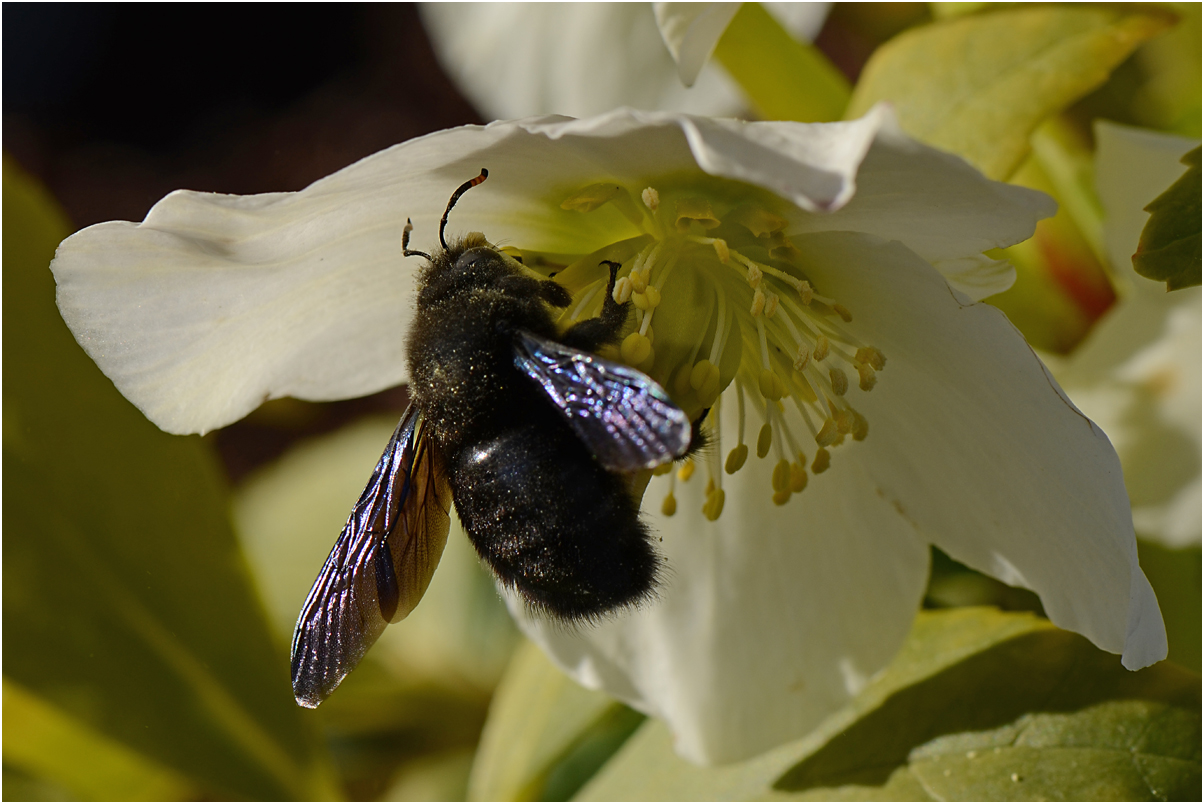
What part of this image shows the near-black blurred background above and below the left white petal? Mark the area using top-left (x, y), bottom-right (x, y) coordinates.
top-left (4, 2), bottom-right (482, 483)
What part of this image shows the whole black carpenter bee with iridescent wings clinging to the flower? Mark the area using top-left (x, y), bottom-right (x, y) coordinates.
top-left (291, 170), bottom-right (698, 707)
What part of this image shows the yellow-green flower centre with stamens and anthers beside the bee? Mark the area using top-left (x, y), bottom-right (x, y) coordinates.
top-left (506, 183), bottom-right (886, 520)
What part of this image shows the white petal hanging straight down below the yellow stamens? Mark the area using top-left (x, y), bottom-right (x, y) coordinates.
top-left (512, 423), bottom-right (928, 764)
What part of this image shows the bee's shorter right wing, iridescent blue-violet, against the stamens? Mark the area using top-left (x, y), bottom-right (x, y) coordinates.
top-left (514, 332), bottom-right (691, 472)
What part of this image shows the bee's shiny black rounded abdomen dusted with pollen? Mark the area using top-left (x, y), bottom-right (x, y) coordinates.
top-left (449, 423), bottom-right (660, 621)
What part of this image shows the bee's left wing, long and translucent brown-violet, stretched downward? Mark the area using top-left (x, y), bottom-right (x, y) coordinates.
top-left (293, 404), bottom-right (452, 709)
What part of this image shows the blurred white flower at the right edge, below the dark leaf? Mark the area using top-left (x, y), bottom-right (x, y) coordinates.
top-left (1047, 120), bottom-right (1202, 548)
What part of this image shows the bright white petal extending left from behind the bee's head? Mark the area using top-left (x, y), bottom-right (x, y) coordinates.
top-left (51, 119), bottom-right (514, 433)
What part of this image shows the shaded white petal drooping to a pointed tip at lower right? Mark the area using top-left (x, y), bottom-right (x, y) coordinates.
top-left (796, 232), bottom-right (1167, 668)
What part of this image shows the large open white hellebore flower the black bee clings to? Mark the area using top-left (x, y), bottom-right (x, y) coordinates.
top-left (52, 108), bottom-right (1167, 762)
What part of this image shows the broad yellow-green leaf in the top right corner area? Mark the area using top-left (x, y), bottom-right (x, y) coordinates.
top-left (845, 5), bottom-right (1173, 179)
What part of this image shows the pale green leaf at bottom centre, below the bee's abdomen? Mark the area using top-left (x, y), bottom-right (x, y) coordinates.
top-left (468, 643), bottom-right (644, 802)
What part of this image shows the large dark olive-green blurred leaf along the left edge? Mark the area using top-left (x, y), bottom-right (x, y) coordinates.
top-left (4, 161), bottom-right (337, 798)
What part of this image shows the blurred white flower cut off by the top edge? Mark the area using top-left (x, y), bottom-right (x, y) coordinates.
top-left (419, 2), bottom-right (831, 118)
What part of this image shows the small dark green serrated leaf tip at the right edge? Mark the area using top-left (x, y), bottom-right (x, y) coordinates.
top-left (1133, 147), bottom-right (1200, 290)
